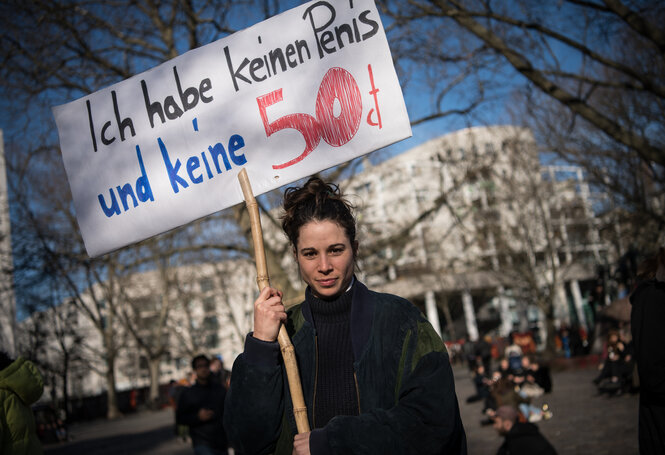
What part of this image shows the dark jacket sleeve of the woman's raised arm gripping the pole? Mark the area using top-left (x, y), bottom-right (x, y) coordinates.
top-left (224, 333), bottom-right (284, 454)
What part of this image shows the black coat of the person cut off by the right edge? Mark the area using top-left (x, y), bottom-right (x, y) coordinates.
top-left (630, 280), bottom-right (665, 454)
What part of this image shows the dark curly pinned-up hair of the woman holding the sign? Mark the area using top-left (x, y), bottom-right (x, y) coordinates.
top-left (282, 177), bottom-right (356, 248)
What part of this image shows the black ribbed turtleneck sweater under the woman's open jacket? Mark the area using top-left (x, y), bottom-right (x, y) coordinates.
top-left (307, 289), bottom-right (359, 428)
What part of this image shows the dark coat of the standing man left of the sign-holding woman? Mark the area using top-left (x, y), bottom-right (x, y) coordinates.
top-left (176, 381), bottom-right (228, 451)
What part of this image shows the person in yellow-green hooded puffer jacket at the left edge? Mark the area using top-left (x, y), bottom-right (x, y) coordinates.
top-left (0, 351), bottom-right (44, 455)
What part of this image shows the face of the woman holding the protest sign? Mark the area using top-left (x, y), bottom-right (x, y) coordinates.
top-left (295, 220), bottom-right (357, 300)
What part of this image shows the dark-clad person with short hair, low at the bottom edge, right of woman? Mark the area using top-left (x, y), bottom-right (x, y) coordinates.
top-left (494, 406), bottom-right (556, 455)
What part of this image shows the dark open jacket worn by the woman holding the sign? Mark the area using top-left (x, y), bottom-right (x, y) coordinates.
top-left (224, 282), bottom-right (466, 455)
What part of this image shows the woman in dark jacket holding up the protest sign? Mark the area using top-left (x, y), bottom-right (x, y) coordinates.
top-left (224, 178), bottom-right (466, 455)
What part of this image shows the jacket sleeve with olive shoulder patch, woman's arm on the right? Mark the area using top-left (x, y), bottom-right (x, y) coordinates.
top-left (310, 321), bottom-right (466, 454)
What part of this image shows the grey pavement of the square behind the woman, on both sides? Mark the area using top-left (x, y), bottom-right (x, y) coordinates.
top-left (44, 362), bottom-right (639, 455)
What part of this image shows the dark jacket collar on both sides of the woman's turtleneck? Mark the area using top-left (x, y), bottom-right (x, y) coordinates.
top-left (302, 277), bottom-right (374, 362)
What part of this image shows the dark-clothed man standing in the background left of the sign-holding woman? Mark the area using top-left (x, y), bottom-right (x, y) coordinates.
top-left (176, 355), bottom-right (228, 455)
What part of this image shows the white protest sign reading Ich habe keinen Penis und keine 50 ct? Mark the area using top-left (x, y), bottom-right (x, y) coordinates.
top-left (53, 0), bottom-right (411, 257)
